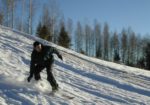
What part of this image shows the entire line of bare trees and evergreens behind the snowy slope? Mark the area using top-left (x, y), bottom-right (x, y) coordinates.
top-left (0, 0), bottom-right (150, 70)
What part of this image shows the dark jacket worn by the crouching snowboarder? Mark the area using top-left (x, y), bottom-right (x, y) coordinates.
top-left (30, 45), bottom-right (62, 77)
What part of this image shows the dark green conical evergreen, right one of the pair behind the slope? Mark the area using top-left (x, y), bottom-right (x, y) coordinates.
top-left (58, 26), bottom-right (71, 48)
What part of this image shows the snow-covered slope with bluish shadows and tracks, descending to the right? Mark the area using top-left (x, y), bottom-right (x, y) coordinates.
top-left (0, 26), bottom-right (150, 105)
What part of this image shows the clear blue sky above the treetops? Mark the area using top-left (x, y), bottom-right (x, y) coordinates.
top-left (58, 0), bottom-right (150, 34)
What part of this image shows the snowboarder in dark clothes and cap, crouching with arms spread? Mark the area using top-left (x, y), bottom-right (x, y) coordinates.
top-left (27, 41), bottom-right (63, 91)
